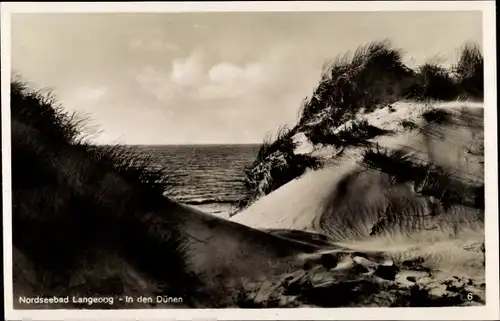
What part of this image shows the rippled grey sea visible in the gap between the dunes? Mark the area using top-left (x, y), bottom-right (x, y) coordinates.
top-left (135, 144), bottom-right (260, 217)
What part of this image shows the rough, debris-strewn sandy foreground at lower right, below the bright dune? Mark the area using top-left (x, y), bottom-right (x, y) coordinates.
top-left (178, 200), bottom-right (484, 308)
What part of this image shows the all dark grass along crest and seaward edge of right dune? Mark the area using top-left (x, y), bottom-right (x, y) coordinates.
top-left (240, 40), bottom-right (484, 208)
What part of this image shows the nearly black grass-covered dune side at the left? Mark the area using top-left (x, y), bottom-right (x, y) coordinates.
top-left (11, 80), bottom-right (201, 306)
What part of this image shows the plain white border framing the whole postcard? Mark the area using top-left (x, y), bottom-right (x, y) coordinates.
top-left (1, 1), bottom-right (500, 320)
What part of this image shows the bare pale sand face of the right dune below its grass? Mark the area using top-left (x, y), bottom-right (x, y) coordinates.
top-left (232, 103), bottom-right (484, 305)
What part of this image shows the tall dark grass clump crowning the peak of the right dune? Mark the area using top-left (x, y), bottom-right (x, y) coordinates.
top-left (299, 40), bottom-right (412, 125)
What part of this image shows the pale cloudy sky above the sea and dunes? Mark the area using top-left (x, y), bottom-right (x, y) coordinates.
top-left (11, 11), bottom-right (482, 144)
